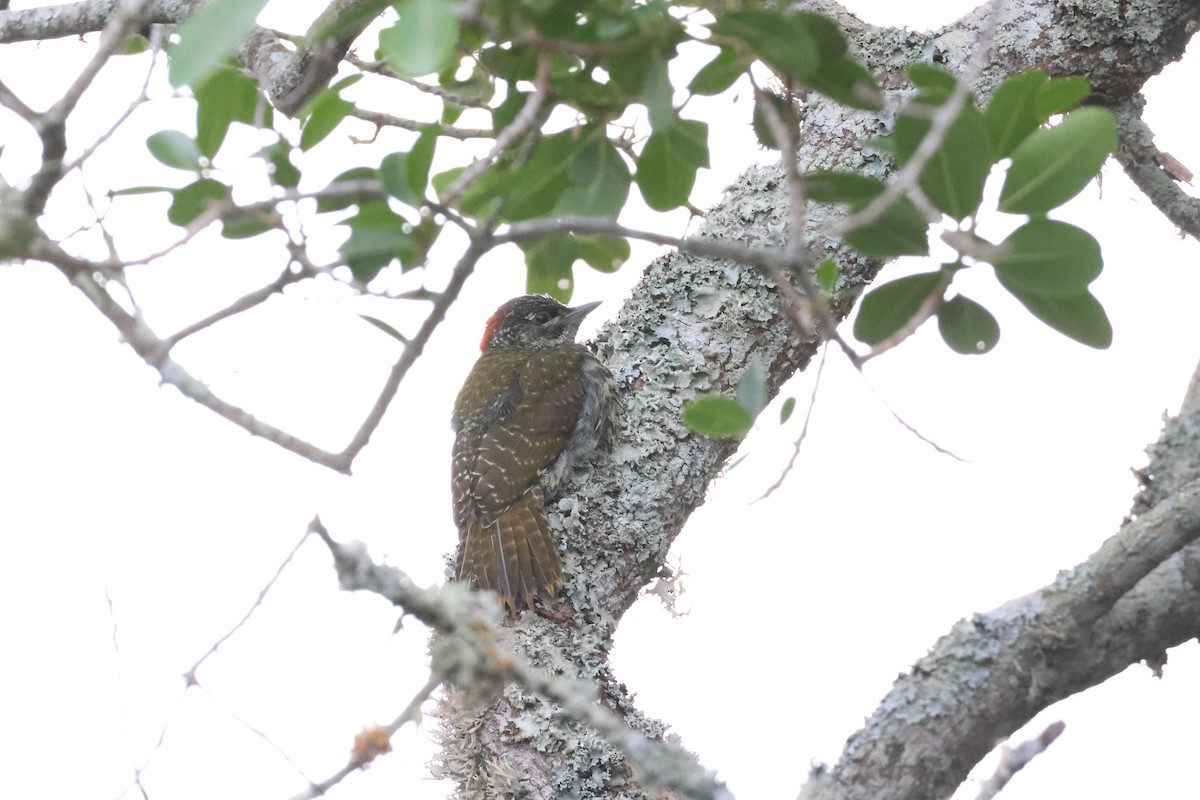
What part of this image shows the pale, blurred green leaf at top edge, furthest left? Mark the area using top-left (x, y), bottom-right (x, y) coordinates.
top-left (169, 0), bottom-right (266, 86)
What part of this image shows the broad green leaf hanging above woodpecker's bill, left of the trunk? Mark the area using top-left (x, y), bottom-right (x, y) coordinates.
top-left (635, 120), bottom-right (708, 211)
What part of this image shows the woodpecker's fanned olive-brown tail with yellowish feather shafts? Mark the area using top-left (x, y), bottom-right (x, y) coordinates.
top-left (455, 488), bottom-right (563, 616)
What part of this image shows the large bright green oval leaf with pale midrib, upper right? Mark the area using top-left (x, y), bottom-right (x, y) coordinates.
top-left (1000, 107), bottom-right (1117, 213)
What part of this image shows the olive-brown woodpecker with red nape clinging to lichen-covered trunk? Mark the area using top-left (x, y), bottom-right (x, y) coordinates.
top-left (451, 295), bottom-right (620, 616)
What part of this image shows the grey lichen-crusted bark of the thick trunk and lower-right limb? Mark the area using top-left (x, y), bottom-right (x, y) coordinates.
top-left (443, 0), bottom-right (1200, 799)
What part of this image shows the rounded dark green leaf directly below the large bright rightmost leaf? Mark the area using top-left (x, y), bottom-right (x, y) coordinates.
top-left (992, 219), bottom-right (1104, 296)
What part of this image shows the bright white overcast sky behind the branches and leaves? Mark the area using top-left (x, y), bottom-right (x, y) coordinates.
top-left (0, 4), bottom-right (1200, 800)
